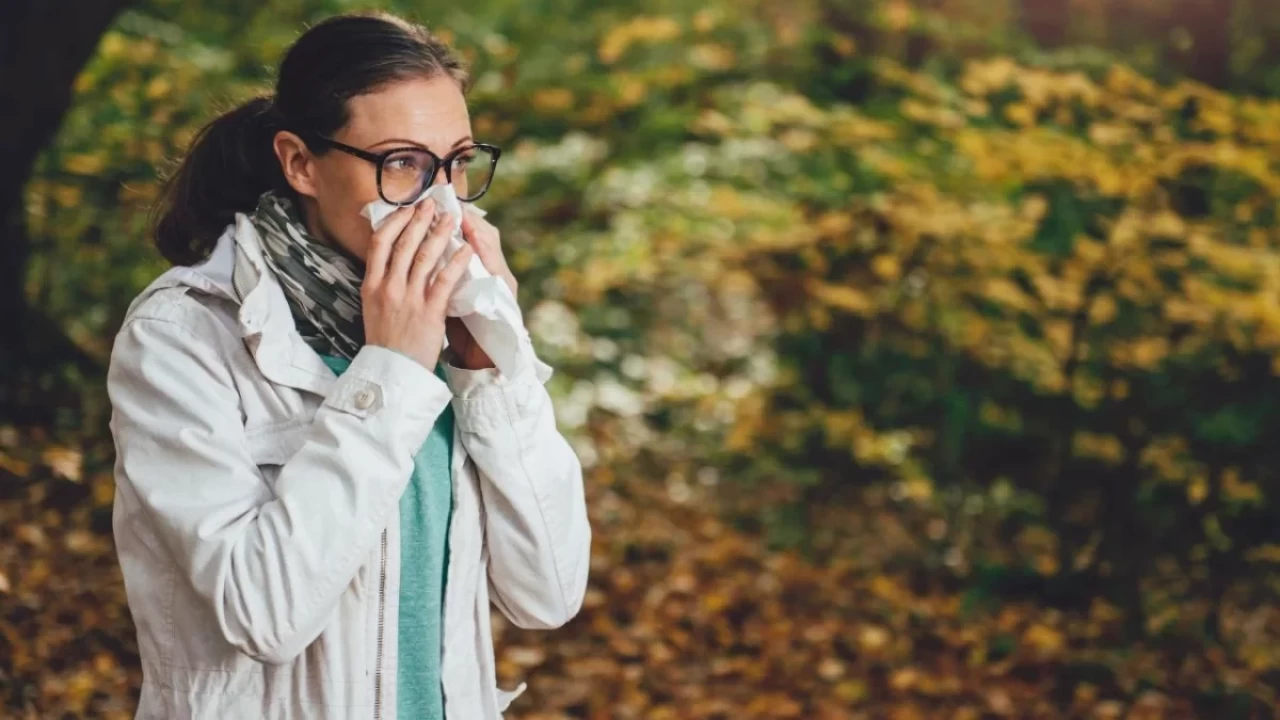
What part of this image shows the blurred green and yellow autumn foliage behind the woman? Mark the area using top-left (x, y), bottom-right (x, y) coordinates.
top-left (28, 0), bottom-right (1280, 633)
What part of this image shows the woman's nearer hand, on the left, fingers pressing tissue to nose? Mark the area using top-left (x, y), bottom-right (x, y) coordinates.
top-left (360, 200), bottom-right (475, 370)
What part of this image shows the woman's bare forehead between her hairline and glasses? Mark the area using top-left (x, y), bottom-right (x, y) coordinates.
top-left (337, 76), bottom-right (471, 154)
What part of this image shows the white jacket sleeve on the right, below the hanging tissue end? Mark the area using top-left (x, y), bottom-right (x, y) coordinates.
top-left (444, 359), bottom-right (591, 629)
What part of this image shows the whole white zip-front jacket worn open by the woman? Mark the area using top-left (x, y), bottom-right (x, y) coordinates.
top-left (108, 215), bottom-right (591, 720)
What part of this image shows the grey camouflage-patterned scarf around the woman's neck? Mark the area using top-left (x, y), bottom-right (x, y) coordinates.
top-left (250, 192), bottom-right (365, 360)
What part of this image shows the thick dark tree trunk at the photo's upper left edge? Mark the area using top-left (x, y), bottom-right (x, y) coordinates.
top-left (0, 0), bottom-right (131, 392)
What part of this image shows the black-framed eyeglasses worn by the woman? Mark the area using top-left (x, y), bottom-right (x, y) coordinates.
top-left (307, 135), bottom-right (502, 205)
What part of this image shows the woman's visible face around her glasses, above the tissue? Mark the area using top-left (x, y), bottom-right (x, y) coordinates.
top-left (276, 76), bottom-right (474, 260)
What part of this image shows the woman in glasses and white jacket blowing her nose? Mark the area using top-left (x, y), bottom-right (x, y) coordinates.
top-left (109, 14), bottom-right (590, 720)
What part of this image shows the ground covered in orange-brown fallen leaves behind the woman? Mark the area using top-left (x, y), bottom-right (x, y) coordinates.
top-left (0, 428), bottom-right (1280, 720)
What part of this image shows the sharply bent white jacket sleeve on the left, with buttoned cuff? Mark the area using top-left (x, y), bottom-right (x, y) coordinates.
top-left (108, 306), bottom-right (451, 664)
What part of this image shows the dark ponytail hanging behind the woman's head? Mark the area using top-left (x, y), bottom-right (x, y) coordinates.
top-left (152, 96), bottom-right (287, 265)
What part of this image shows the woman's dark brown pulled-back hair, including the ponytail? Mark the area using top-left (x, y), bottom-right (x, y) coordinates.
top-left (152, 13), bottom-right (467, 265)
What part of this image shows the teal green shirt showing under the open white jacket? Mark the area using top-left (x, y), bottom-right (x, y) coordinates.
top-left (323, 355), bottom-right (453, 720)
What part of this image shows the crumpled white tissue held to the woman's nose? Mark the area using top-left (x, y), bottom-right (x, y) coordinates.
top-left (360, 184), bottom-right (532, 377)
